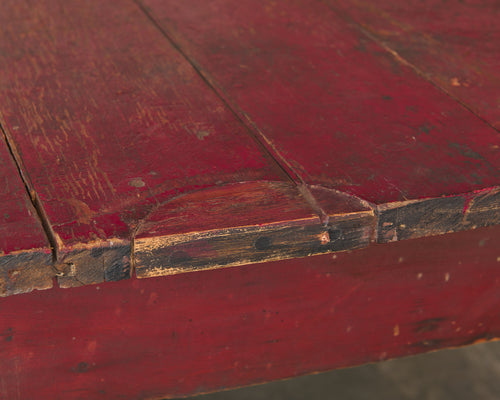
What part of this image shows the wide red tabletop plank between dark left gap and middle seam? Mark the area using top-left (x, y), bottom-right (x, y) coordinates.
top-left (0, 0), bottom-right (352, 287)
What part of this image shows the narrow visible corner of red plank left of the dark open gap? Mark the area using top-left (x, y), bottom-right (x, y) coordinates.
top-left (0, 127), bottom-right (53, 297)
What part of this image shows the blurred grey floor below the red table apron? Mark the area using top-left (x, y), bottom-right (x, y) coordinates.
top-left (184, 342), bottom-right (500, 400)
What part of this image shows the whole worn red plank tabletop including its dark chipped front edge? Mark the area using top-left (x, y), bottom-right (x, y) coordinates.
top-left (0, 0), bottom-right (500, 398)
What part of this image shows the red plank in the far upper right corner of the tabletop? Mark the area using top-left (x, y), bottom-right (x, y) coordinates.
top-left (326, 0), bottom-right (500, 129)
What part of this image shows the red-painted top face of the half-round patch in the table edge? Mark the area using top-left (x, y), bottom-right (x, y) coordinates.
top-left (136, 182), bottom-right (320, 237)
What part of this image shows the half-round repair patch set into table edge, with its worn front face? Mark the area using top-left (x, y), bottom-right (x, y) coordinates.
top-left (134, 182), bottom-right (375, 278)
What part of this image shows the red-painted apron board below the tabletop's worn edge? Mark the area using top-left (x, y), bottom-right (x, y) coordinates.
top-left (0, 226), bottom-right (500, 400)
